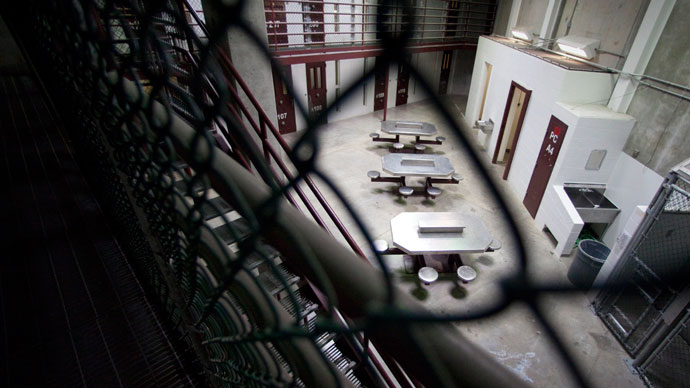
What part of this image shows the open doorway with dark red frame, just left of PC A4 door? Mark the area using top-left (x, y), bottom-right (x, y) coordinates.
top-left (491, 82), bottom-right (532, 179)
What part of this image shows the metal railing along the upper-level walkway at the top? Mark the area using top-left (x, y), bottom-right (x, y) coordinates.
top-left (264, 0), bottom-right (497, 51)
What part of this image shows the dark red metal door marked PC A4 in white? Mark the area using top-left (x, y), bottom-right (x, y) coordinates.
top-left (522, 116), bottom-right (568, 218)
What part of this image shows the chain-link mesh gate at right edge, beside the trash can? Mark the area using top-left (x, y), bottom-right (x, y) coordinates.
top-left (597, 172), bottom-right (690, 387)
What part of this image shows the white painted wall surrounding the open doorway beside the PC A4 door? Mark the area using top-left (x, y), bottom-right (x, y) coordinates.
top-left (465, 37), bottom-right (625, 197)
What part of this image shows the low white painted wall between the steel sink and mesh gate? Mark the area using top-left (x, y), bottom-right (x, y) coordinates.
top-left (603, 152), bottom-right (664, 247)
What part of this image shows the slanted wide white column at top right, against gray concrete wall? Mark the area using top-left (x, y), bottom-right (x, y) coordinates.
top-left (608, 0), bottom-right (672, 113)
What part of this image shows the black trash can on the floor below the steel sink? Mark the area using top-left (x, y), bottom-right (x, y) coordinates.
top-left (568, 240), bottom-right (611, 290)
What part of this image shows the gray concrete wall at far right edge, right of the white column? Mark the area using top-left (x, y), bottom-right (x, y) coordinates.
top-left (624, 0), bottom-right (690, 176)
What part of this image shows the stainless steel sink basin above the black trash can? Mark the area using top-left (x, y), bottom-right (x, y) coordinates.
top-left (564, 186), bottom-right (620, 224)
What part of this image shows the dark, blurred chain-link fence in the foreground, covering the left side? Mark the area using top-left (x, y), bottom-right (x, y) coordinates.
top-left (1, 0), bottom-right (672, 387)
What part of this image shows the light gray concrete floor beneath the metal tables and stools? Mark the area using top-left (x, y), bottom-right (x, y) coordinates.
top-left (286, 96), bottom-right (644, 387)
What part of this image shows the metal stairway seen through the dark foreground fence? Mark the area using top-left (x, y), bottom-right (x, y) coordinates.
top-left (174, 164), bottom-right (371, 387)
